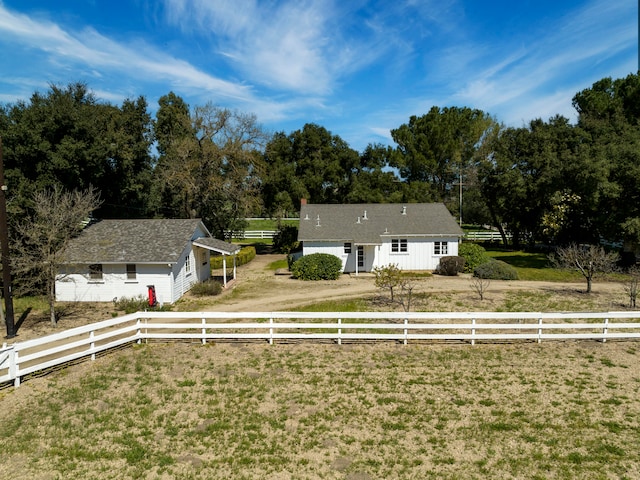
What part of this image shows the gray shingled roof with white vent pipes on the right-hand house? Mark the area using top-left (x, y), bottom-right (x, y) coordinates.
top-left (298, 203), bottom-right (463, 245)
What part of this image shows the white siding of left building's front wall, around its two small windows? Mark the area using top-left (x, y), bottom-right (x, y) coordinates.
top-left (56, 264), bottom-right (172, 303)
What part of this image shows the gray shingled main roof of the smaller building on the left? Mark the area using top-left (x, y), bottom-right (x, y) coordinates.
top-left (64, 219), bottom-right (208, 263)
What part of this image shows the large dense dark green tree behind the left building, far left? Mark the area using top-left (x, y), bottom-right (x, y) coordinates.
top-left (0, 83), bottom-right (152, 219)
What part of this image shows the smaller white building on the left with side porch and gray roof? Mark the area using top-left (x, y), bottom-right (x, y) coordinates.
top-left (56, 219), bottom-right (240, 303)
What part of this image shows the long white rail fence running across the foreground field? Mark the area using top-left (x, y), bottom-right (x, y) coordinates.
top-left (0, 311), bottom-right (640, 386)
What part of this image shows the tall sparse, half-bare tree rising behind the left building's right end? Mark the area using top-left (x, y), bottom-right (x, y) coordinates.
top-left (157, 104), bottom-right (268, 238)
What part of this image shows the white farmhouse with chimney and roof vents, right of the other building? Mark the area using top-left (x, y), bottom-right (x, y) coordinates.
top-left (298, 201), bottom-right (464, 274)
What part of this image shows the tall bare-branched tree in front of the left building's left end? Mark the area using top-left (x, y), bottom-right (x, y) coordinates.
top-left (16, 187), bottom-right (101, 325)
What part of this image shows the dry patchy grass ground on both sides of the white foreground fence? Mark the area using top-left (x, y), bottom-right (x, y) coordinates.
top-left (0, 253), bottom-right (640, 480)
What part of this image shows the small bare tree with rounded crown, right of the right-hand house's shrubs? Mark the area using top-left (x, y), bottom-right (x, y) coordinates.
top-left (550, 243), bottom-right (618, 293)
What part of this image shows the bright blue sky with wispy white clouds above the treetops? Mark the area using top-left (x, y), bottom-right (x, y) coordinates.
top-left (0, 0), bottom-right (638, 150)
